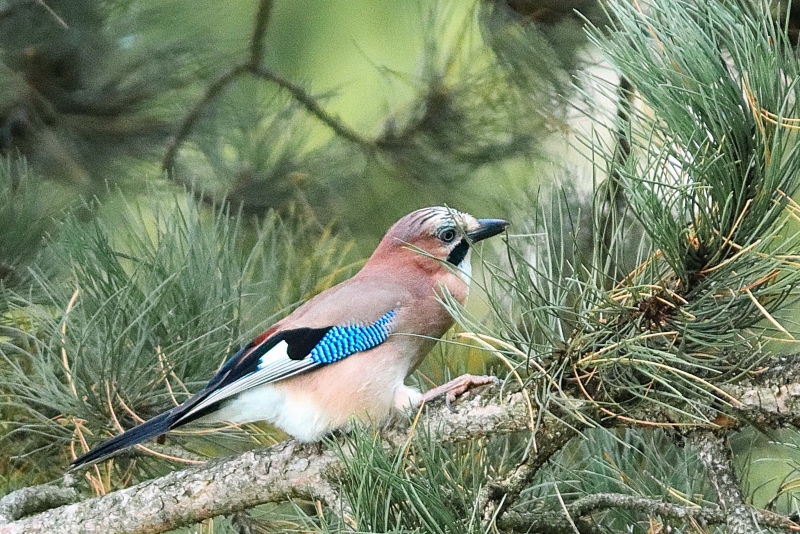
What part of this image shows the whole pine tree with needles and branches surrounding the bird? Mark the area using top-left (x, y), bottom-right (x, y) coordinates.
top-left (0, 0), bottom-right (800, 533)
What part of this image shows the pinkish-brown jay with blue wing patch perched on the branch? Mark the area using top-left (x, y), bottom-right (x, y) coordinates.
top-left (69, 206), bottom-right (509, 471)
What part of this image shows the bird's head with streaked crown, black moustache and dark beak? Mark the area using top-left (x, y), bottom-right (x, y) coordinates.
top-left (365, 206), bottom-right (508, 298)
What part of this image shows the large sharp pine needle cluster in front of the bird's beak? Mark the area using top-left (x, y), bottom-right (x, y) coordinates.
top-left (444, 2), bottom-right (800, 430)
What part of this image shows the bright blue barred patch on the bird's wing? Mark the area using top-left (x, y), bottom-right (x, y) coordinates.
top-left (309, 310), bottom-right (395, 364)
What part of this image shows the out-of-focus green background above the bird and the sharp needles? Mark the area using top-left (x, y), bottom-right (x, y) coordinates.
top-left (0, 0), bottom-right (599, 267)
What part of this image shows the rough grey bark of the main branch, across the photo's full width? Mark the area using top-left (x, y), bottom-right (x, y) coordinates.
top-left (0, 357), bottom-right (800, 534)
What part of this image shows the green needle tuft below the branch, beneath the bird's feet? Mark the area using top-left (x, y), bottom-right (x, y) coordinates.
top-left (298, 430), bottom-right (525, 534)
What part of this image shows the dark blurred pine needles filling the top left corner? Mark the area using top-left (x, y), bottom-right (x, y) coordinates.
top-left (0, 0), bottom-right (203, 187)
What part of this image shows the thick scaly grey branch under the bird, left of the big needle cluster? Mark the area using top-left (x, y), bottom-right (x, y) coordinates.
top-left (0, 388), bottom-right (528, 534)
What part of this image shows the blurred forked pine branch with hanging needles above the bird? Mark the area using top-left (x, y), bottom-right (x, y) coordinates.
top-left (161, 0), bottom-right (552, 211)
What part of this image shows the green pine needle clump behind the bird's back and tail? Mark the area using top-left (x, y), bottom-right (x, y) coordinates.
top-left (0, 197), bottom-right (351, 486)
